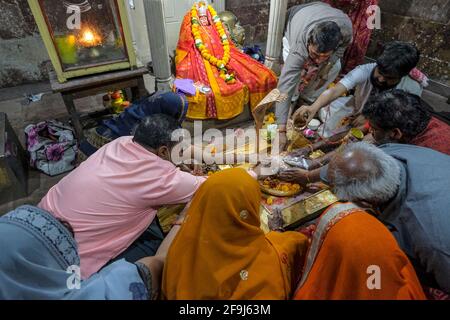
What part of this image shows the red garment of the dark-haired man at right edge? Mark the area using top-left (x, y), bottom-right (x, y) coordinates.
top-left (410, 117), bottom-right (450, 155)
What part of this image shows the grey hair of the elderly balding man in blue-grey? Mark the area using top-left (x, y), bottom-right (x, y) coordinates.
top-left (333, 142), bottom-right (400, 204)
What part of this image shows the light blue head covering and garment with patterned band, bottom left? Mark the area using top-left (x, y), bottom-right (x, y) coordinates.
top-left (0, 206), bottom-right (149, 300)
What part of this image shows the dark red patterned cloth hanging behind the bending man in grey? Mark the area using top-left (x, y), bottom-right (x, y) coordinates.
top-left (323, 0), bottom-right (378, 74)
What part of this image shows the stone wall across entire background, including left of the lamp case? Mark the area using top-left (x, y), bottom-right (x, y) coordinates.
top-left (0, 0), bottom-right (450, 88)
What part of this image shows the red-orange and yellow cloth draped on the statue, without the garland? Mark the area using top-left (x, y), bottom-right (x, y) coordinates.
top-left (175, 11), bottom-right (277, 119)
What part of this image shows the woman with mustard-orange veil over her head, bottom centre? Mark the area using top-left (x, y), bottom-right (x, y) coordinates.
top-left (162, 168), bottom-right (307, 300)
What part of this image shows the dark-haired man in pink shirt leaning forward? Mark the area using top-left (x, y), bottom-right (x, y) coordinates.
top-left (38, 114), bottom-right (205, 279)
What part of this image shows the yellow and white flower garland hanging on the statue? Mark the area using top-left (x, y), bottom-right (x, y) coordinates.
top-left (191, 4), bottom-right (236, 84)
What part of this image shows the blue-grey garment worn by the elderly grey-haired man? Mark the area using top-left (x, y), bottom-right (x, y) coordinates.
top-left (379, 144), bottom-right (450, 292)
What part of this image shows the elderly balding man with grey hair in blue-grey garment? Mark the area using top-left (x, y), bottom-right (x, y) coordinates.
top-left (321, 142), bottom-right (450, 292)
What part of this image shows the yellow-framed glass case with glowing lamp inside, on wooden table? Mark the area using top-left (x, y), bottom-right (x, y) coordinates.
top-left (28, 0), bottom-right (137, 83)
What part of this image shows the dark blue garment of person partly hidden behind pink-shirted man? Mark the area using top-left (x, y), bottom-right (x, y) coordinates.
top-left (103, 92), bottom-right (188, 138)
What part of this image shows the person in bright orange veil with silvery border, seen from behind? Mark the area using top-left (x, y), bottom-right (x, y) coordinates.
top-left (294, 203), bottom-right (425, 300)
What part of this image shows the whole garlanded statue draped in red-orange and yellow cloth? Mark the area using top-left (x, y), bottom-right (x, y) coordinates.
top-left (175, 1), bottom-right (277, 119)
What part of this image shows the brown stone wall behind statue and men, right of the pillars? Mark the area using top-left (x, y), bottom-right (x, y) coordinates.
top-left (230, 0), bottom-right (450, 85)
